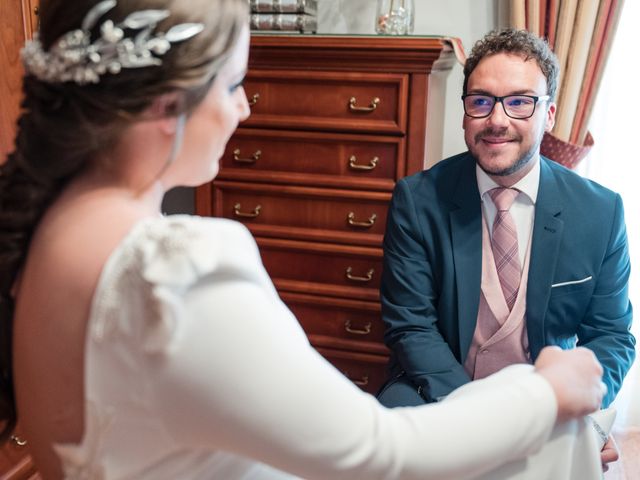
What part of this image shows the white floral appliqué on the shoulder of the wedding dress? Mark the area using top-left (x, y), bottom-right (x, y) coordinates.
top-left (92, 216), bottom-right (224, 353)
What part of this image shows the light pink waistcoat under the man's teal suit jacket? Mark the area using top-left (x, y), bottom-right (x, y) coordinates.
top-left (464, 221), bottom-right (531, 380)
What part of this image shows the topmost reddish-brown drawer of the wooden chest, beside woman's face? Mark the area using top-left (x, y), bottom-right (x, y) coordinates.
top-left (244, 69), bottom-right (408, 135)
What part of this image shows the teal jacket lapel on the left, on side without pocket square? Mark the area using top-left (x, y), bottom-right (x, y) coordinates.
top-left (449, 155), bottom-right (482, 362)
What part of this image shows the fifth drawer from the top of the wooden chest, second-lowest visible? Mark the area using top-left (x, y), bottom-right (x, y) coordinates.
top-left (279, 292), bottom-right (388, 355)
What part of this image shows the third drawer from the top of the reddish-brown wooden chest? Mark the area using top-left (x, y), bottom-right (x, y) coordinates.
top-left (213, 181), bottom-right (391, 246)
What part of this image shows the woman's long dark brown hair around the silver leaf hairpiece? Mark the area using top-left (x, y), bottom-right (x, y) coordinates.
top-left (0, 0), bottom-right (248, 439)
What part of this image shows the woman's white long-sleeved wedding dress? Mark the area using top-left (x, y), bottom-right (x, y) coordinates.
top-left (55, 216), bottom-right (599, 480)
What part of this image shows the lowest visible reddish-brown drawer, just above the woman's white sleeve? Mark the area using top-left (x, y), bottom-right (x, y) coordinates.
top-left (316, 347), bottom-right (388, 395)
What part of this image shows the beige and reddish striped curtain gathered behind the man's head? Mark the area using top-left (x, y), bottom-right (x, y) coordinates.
top-left (510, 0), bottom-right (624, 167)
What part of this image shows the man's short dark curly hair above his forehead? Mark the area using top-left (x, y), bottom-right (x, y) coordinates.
top-left (462, 28), bottom-right (560, 101)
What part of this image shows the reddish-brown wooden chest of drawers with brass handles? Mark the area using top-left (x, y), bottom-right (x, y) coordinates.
top-left (196, 35), bottom-right (453, 393)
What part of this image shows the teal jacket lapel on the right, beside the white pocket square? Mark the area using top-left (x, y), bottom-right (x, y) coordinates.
top-left (527, 158), bottom-right (564, 358)
